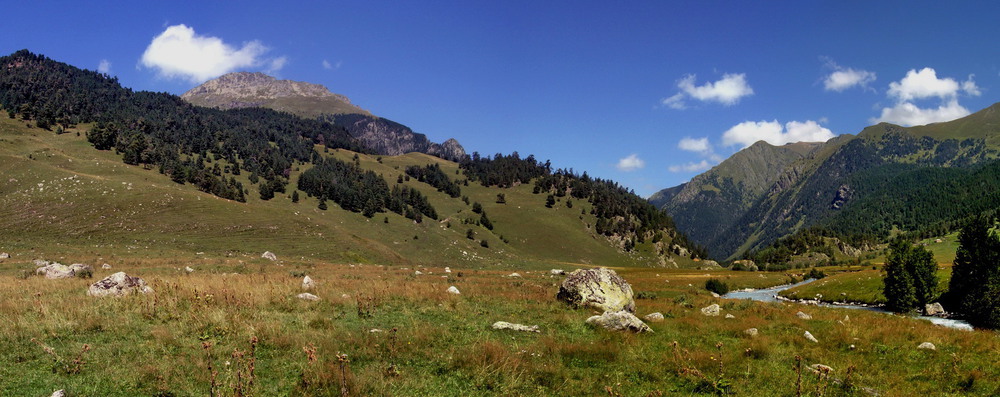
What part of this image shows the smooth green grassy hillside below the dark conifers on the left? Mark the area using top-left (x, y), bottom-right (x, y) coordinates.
top-left (0, 118), bottom-right (691, 267)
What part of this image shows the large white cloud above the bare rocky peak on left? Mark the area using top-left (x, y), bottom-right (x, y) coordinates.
top-left (140, 24), bottom-right (287, 83)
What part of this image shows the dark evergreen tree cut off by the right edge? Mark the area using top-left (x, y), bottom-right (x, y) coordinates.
top-left (948, 216), bottom-right (1000, 329)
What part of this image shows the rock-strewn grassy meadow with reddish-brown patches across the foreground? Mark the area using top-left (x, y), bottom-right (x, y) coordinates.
top-left (0, 253), bottom-right (1000, 396)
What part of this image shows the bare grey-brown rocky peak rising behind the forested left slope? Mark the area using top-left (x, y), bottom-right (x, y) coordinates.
top-left (181, 72), bottom-right (465, 160)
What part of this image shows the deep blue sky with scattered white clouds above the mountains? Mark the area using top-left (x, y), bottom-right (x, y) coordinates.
top-left (0, 1), bottom-right (1000, 196)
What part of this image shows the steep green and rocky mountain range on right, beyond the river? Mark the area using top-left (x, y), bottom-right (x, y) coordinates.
top-left (650, 104), bottom-right (1000, 259)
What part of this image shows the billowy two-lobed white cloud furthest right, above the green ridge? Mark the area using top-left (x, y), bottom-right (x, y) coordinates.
top-left (870, 67), bottom-right (982, 126)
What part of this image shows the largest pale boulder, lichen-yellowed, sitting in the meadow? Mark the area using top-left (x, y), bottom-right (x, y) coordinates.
top-left (556, 267), bottom-right (635, 313)
